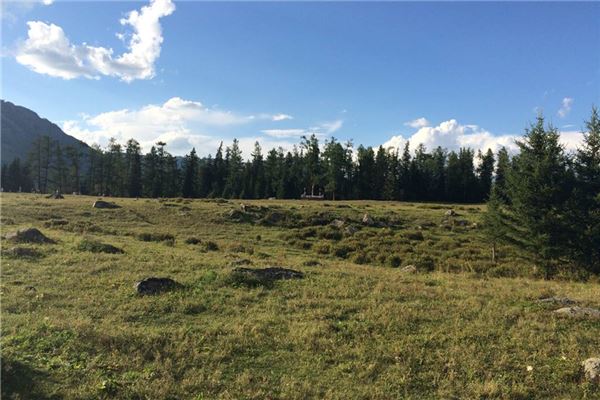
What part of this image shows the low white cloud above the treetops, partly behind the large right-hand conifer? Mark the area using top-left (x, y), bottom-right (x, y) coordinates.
top-left (383, 119), bottom-right (583, 152)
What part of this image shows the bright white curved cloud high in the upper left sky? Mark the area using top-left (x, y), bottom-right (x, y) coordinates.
top-left (16, 0), bottom-right (175, 82)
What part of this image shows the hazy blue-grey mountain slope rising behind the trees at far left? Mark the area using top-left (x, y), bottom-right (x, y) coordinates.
top-left (0, 100), bottom-right (87, 163)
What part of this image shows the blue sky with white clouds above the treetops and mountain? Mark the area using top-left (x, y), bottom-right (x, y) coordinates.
top-left (2, 0), bottom-right (600, 154)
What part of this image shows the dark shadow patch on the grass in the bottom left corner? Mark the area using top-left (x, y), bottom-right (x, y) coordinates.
top-left (1, 358), bottom-right (60, 400)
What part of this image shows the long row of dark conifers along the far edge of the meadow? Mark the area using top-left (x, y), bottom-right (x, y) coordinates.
top-left (2, 135), bottom-right (500, 203)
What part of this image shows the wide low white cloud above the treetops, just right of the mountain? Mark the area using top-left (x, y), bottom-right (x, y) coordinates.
top-left (62, 97), bottom-right (318, 157)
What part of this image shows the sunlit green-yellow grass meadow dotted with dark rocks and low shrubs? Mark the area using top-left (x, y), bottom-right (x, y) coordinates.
top-left (1, 193), bottom-right (600, 399)
